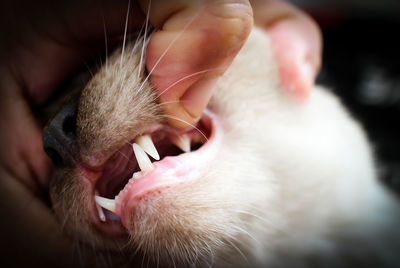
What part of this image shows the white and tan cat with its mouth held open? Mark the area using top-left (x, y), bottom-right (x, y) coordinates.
top-left (43, 25), bottom-right (400, 267)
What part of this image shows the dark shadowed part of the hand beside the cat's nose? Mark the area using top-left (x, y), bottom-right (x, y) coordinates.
top-left (0, 0), bottom-right (251, 267)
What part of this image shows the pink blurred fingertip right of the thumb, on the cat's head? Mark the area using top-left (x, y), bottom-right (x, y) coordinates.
top-left (268, 19), bottom-right (320, 99)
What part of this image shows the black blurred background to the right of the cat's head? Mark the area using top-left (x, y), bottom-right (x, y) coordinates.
top-left (291, 0), bottom-right (400, 196)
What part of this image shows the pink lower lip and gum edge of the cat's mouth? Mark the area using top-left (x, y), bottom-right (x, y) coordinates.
top-left (84, 110), bottom-right (223, 233)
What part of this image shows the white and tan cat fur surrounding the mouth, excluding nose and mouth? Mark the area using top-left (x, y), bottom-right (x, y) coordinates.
top-left (51, 26), bottom-right (400, 267)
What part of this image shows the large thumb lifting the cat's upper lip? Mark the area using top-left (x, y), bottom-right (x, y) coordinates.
top-left (142, 0), bottom-right (253, 128)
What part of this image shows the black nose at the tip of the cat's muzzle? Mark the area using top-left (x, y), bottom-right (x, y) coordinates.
top-left (43, 104), bottom-right (78, 167)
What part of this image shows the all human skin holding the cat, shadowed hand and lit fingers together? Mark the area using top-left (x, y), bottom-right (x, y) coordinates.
top-left (0, 0), bottom-right (321, 266)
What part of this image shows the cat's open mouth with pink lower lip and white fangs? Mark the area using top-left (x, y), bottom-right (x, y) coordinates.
top-left (86, 111), bottom-right (222, 233)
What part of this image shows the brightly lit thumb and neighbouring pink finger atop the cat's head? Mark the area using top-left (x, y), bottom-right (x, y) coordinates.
top-left (152, 0), bottom-right (322, 128)
